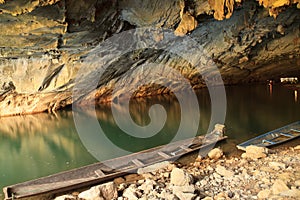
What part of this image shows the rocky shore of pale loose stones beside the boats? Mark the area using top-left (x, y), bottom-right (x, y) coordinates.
top-left (55, 145), bottom-right (300, 200)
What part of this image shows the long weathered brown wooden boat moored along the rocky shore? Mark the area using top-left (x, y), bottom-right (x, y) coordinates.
top-left (3, 126), bottom-right (227, 200)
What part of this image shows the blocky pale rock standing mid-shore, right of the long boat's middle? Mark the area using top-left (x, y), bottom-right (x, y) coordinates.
top-left (170, 168), bottom-right (192, 186)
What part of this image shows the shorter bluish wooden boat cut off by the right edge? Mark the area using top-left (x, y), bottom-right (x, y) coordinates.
top-left (237, 121), bottom-right (300, 151)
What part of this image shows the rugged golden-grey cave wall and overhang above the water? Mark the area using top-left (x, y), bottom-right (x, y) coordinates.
top-left (0, 0), bottom-right (300, 116)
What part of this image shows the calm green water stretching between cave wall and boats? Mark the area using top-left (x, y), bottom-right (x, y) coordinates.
top-left (0, 85), bottom-right (300, 197)
